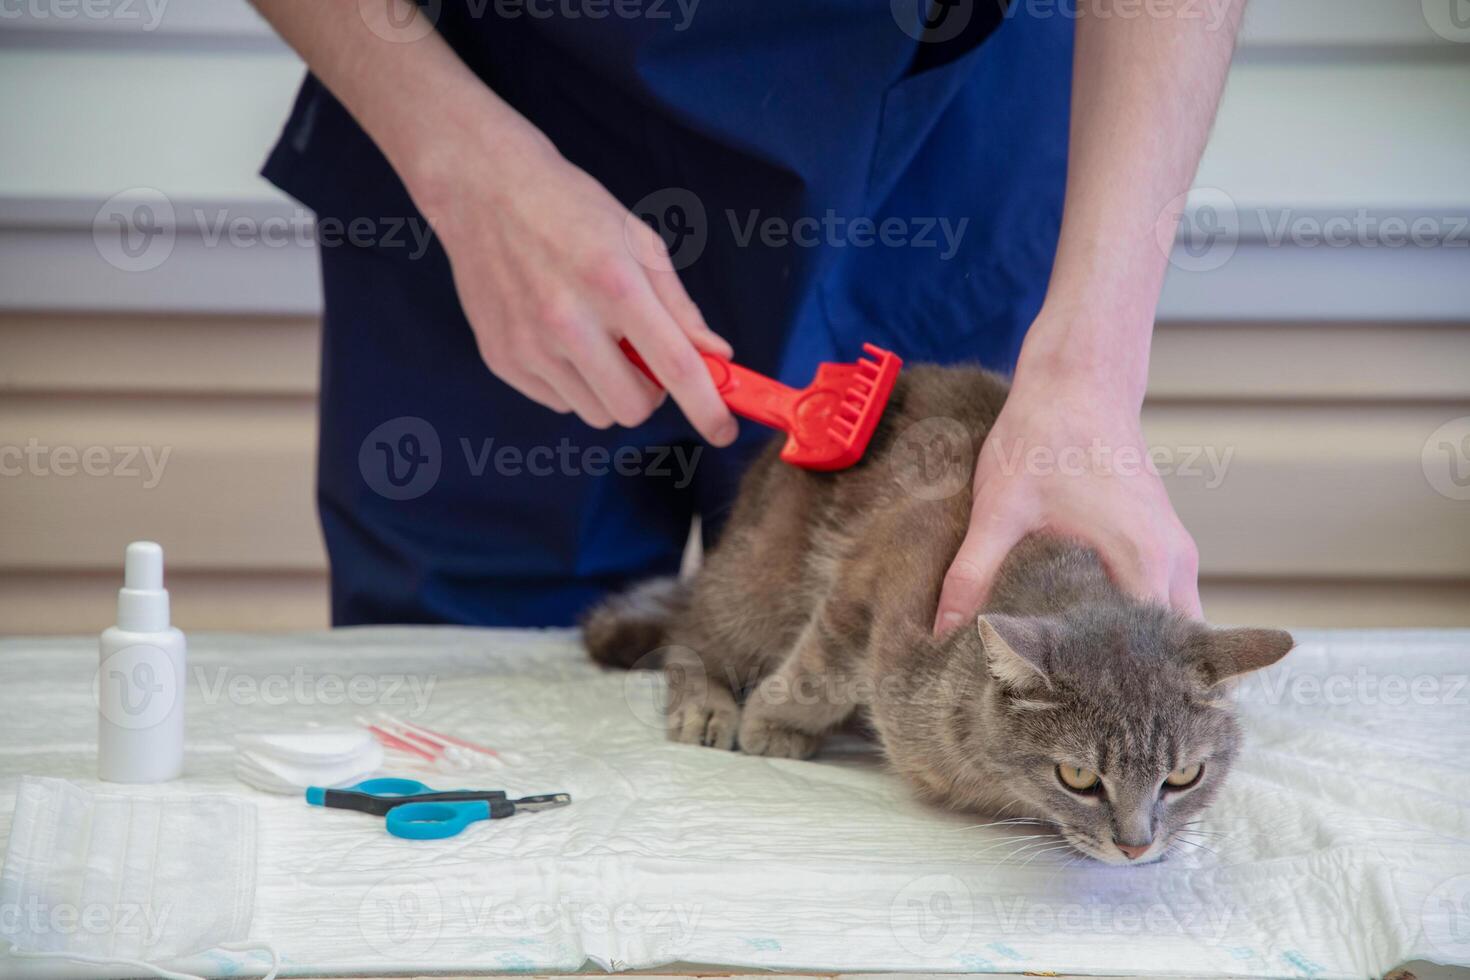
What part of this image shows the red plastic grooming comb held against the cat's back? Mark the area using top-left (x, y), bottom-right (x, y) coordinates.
top-left (622, 341), bottom-right (904, 470)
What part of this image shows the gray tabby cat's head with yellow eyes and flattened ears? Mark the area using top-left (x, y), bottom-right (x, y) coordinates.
top-left (966, 604), bottom-right (1294, 864)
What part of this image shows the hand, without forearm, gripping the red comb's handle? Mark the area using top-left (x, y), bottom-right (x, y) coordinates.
top-left (410, 134), bottom-right (736, 445)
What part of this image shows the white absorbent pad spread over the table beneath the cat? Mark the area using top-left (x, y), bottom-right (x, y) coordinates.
top-left (0, 629), bottom-right (1470, 977)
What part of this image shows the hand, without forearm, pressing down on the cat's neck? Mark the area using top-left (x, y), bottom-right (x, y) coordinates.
top-left (935, 332), bottom-right (1202, 633)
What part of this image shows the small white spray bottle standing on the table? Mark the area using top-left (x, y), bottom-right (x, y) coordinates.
top-left (97, 541), bottom-right (185, 783)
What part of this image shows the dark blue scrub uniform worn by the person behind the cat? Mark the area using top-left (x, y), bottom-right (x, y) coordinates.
top-left (265, 0), bottom-right (1073, 626)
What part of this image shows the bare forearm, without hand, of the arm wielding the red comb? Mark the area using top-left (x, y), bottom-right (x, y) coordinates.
top-left (251, 0), bottom-right (550, 215)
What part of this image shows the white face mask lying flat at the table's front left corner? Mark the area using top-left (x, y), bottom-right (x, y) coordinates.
top-left (0, 776), bottom-right (275, 977)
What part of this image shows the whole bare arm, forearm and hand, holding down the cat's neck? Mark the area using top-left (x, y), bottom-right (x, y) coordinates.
top-left (935, 0), bottom-right (1245, 630)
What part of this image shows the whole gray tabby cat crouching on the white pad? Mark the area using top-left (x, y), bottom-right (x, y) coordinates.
top-left (584, 366), bottom-right (1292, 864)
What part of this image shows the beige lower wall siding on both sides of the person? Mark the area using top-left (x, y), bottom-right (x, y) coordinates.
top-left (0, 314), bottom-right (1470, 632)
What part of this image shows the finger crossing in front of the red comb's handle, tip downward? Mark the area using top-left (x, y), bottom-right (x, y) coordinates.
top-left (626, 279), bottom-right (739, 445)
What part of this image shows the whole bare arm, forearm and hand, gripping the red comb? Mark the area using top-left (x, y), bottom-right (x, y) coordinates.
top-left (251, 0), bottom-right (736, 445)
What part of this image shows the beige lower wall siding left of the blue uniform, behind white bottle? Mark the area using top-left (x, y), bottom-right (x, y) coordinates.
top-left (0, 314), bottom-right (328, 633)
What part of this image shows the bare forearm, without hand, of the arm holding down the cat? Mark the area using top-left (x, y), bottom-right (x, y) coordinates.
top-left (1017, 0), bottom-right (1245, 406)
